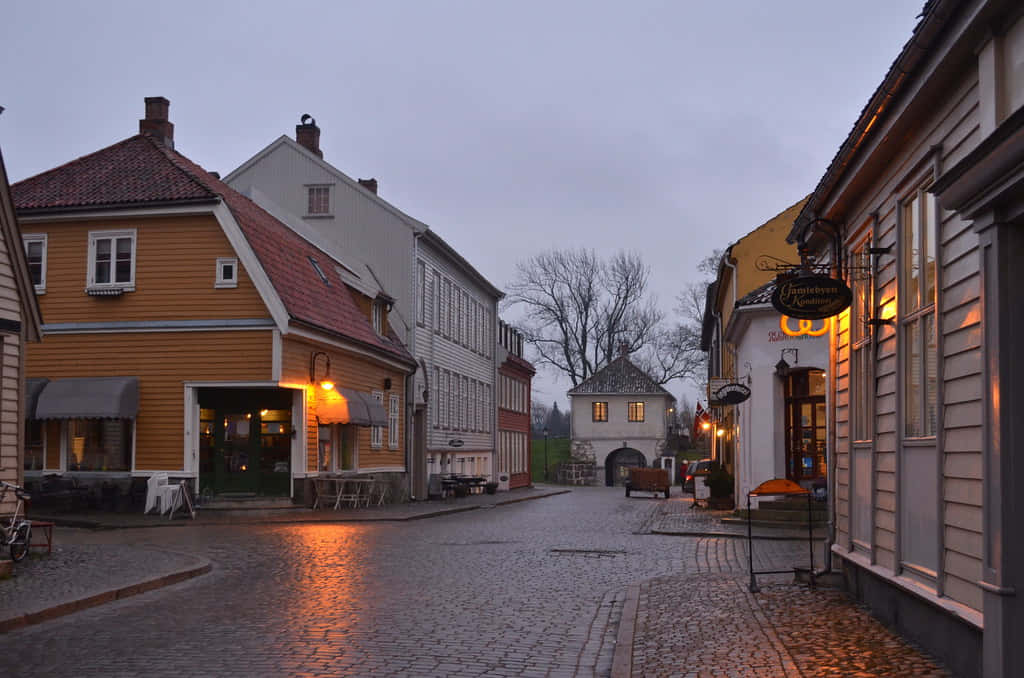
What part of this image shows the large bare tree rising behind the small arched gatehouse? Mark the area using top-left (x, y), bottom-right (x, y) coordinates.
top-left (505, 249), bottom-right (695, 386)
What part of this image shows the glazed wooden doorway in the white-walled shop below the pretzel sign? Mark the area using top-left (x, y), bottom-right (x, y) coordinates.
top-left (785, 370), bottom-right (827, 488)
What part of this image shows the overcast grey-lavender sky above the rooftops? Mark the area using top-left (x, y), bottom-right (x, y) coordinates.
top-left (0, 0), bottom-right (924, 407)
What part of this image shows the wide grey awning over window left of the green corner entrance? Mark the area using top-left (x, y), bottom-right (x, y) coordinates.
top-left (36, 377), bottom-right (138, 419)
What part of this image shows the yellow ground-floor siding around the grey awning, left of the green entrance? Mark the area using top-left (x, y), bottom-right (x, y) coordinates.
top-left (27, 330), bottom-right (272, 471)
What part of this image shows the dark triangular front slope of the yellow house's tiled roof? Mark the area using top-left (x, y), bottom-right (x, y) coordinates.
top-left (11, 134), bottom-right (217, 213)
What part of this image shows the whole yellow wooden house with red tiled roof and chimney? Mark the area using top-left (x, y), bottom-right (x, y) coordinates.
top-left (12, 97), bottom-right (416, 498)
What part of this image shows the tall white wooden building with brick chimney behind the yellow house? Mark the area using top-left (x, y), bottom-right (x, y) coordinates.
top-left (225, 116), bottom-right (503, 499)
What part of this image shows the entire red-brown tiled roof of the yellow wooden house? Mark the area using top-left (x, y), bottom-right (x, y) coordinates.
top-left (11, 134), bottom-right (415, 365)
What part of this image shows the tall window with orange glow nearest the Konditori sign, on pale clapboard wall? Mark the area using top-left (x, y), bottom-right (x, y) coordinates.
top-left (849, 241), bottom-right (874, 440)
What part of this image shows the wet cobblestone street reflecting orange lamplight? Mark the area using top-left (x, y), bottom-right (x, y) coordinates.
top-left (0, 488), bottom-right (943, 677)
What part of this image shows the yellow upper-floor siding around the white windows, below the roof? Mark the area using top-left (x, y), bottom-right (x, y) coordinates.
top-left (23, 215), bottom-right (269, 324)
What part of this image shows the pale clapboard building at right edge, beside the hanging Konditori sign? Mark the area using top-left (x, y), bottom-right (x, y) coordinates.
top-left (790, 0), bottom-right (1024, 678)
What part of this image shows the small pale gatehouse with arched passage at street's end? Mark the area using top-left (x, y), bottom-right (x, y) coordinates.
top-left (568, 352), bottom-right (676, 485)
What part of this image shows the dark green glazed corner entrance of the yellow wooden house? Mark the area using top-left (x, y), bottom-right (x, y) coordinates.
top-left (199, 388), bottom-right (292, 497)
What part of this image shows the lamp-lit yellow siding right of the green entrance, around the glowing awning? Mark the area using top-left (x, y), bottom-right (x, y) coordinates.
top-left (281, 337), bottom-right (406, 471)
